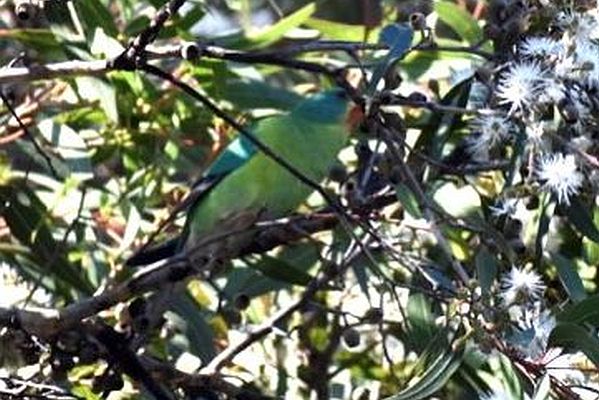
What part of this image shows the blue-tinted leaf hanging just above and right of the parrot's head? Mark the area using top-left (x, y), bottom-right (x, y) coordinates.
top-left (366, 24), bottom-right (414, 96)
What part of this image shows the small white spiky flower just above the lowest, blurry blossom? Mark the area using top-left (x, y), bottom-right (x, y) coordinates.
top-left (501, 267), bottom-right (545, 305)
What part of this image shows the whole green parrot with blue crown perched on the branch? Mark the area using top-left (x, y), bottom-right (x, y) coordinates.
top-left (127, 90), bottom-right (359, 266)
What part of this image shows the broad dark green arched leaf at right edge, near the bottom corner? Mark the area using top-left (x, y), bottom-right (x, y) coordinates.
top-left (549, 322), bottom-right (599, 366)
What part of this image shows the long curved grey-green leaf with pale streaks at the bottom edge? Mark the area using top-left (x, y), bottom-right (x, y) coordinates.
top-left (385, 340), bottom-right (463, 400)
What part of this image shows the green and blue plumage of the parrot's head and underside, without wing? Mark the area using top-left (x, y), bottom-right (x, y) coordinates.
top-left (184, 91), bottom-right (349, 247)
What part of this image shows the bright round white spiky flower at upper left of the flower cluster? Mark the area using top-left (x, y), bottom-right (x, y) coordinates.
top-left (497, 61), bottom-right (545, 114)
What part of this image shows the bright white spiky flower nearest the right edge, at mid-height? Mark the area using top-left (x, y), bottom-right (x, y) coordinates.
top-left (537, 153), bottom-right (583, 205)
